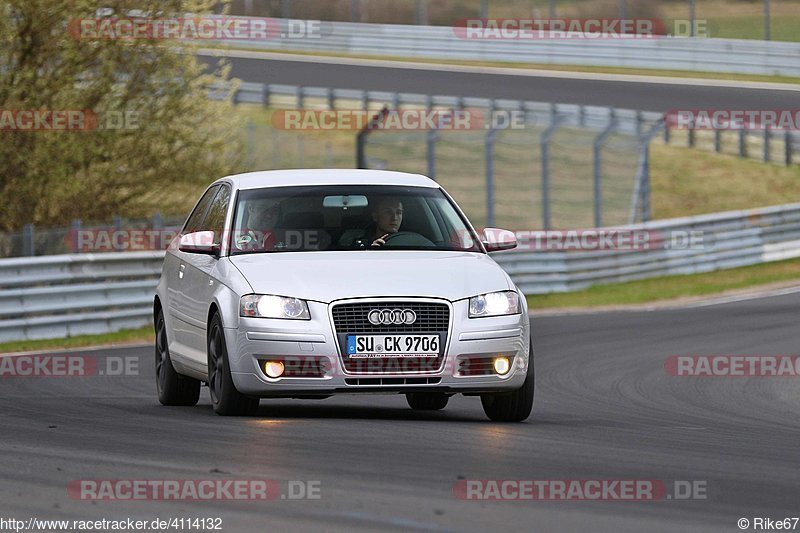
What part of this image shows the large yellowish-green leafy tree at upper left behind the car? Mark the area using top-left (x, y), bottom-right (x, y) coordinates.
top-left (0, 0), bottom-right (242, 231)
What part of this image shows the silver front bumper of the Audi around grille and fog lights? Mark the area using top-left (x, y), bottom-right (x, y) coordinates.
top-left (226, 298), bottom-right (530, 397)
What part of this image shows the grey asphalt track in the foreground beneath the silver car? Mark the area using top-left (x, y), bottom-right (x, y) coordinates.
top-left (0, 293), bottom-right (800, 532)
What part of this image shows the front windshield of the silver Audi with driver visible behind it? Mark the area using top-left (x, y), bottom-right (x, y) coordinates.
top-left (230, 185), bottom-right (482, 255)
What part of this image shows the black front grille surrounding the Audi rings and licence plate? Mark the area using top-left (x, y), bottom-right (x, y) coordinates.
top-left (332, 301), bottom-right (450, 374)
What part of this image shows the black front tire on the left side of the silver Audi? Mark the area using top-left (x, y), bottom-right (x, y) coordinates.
top-left (207, 314), bottom-right (259, 416)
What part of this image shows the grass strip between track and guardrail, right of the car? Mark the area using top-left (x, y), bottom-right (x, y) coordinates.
top-left (527, 259), bottom-right (800, 310)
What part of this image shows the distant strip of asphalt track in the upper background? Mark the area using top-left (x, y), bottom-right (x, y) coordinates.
top-left (201, 56), bottom-right (800, 112)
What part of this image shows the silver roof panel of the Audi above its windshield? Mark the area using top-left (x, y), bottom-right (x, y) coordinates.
top-left (220, 169), bottom-right (438, 189)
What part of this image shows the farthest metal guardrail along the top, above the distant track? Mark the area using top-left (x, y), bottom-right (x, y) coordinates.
top-left (212, 19), bottom-right (800, 76)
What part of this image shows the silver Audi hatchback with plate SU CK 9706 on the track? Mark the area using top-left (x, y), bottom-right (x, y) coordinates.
top-left (153, 170), bottom-right (534, 421)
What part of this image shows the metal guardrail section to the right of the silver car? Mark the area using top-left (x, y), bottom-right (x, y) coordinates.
top-left (492, 204), bottom-right (800, 294)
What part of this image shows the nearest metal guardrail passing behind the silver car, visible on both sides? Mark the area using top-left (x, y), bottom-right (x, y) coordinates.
top-left (0, 204), bottom-right (800, 342)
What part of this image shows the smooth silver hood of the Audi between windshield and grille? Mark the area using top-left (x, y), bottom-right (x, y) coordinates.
top-left (230, 250), bottom-right (511, 303)
